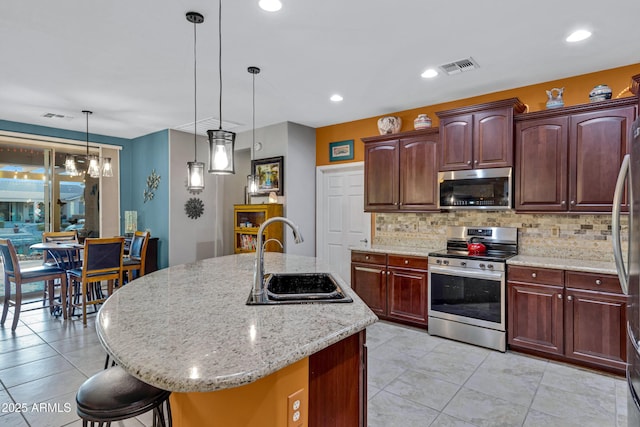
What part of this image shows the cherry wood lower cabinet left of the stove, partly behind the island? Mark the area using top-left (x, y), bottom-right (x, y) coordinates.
top-left (351, 251), bottom-right (429, 327)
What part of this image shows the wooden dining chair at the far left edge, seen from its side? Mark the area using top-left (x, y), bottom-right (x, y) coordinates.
top-left (0, 239), bottom-right (67, 331)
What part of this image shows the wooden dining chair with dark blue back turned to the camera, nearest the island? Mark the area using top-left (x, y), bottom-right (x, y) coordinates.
top-left (67, 237), bottom-right (124, 326)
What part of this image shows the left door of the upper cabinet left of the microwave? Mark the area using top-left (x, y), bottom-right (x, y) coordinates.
top-left (364, 139), bottom-right (399, 212)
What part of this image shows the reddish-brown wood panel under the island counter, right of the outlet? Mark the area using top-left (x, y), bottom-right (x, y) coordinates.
top-left (309, 331), bottom-right (367, 427)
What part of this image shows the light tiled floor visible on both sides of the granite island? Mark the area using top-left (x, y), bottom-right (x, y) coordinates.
top-left (0, 302), bottom-right (626, 427)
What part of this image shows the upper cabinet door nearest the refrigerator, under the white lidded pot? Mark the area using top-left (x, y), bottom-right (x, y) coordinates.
top-left (569, 106), bottom-right (635, 212)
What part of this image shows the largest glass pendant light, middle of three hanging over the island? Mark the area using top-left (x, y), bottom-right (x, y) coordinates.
top-left (207, 0), bottom-right (236, 175)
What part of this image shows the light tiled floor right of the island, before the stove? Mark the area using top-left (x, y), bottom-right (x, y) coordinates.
top-left (367, 322), bottom-right (627, 427)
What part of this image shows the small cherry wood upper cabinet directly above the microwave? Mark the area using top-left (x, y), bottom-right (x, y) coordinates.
top-left (436, 98), bottom-right (525, 171)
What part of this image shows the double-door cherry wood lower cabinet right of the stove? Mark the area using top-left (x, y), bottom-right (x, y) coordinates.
top-left (507, 266), bottom-right (627, 374)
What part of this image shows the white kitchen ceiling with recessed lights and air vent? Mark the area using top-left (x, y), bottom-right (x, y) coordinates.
top-left (0, 0), bottom-right (640, 138)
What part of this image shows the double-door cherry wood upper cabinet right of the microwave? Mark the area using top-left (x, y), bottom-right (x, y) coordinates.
top-left (515, 98), bottom-right (637, 212)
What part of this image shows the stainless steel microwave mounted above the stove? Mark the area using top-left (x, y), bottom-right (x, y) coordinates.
top-left (438, 168), bottom-right (513, 210)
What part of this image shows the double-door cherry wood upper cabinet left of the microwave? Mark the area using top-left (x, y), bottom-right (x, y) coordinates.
top-left (362, 128), bottom-right (438, 212)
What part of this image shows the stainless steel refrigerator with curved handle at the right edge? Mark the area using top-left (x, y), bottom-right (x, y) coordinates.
top-left (612, 115), bottom-right (640, 427)
